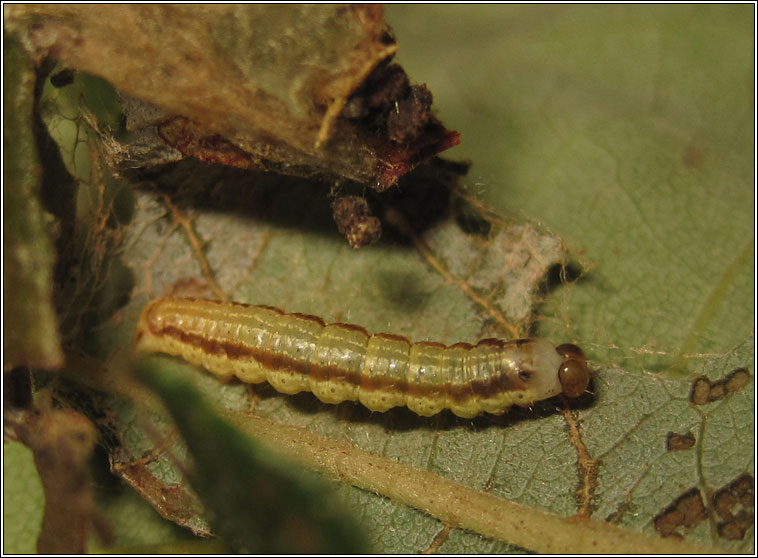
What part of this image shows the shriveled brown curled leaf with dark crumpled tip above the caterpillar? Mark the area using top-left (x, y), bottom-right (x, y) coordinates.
top-left (6, 5), bottom-right (459, 190)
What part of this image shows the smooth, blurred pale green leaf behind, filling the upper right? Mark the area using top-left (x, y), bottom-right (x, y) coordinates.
top-left (388, 5), bottom-right (755, 377)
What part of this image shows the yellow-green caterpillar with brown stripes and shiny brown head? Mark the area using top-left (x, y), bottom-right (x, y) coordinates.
top-left (136, 298), bottom-right (589, 418)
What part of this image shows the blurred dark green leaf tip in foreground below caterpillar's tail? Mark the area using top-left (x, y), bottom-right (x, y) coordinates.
top-left (140, 358), bottom-right (372, 554)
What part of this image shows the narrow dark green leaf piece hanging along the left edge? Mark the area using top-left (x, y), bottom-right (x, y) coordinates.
top-left (3, 34), bottom-right (63, 369)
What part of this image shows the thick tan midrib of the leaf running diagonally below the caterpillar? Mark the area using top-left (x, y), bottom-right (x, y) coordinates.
top-left (223, 412), bottom-right (725, 554)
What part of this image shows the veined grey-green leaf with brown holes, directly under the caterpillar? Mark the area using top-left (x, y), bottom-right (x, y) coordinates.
top-left (93, 150), bottom-right (752, 552)
